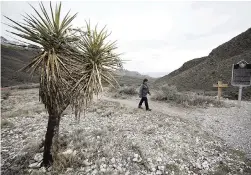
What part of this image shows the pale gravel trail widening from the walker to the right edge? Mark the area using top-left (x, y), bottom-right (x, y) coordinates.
top-left (102, 96), bottom-right (251, 159)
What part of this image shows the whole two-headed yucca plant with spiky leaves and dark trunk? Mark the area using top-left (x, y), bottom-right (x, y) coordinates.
top-left (6, 3), bottom-right (122, 166)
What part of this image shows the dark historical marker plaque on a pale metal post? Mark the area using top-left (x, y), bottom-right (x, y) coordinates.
top-left (231, 60), bottom-right (251, 106)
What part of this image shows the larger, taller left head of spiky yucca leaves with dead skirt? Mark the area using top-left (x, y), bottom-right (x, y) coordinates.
top-left (6, 3), bottom-right (77, 114)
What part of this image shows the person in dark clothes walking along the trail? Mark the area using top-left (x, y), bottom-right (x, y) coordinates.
top-left (138, 79), bottom-right (151, 111)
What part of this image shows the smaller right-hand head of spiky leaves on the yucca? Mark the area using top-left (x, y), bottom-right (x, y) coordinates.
top-left (72, 22), bottom-right (122, 117)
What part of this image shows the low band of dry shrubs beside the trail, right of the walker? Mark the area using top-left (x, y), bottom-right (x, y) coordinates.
top-left (152, 85), bottom-right (223, 107)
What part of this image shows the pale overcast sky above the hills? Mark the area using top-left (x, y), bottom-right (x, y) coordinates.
top-left (1, 1), bottom-right (251, 75)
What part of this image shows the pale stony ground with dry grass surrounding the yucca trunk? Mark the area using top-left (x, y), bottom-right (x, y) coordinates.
top-left (1, 89), bottom-right (251, 175)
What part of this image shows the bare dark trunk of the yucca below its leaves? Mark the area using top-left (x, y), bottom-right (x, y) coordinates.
top-left (42, 114), bottom-right (60, 167)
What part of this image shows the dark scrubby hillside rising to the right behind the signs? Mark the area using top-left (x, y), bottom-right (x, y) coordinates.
top-left (155, 28), bottom-right (251, 100)
